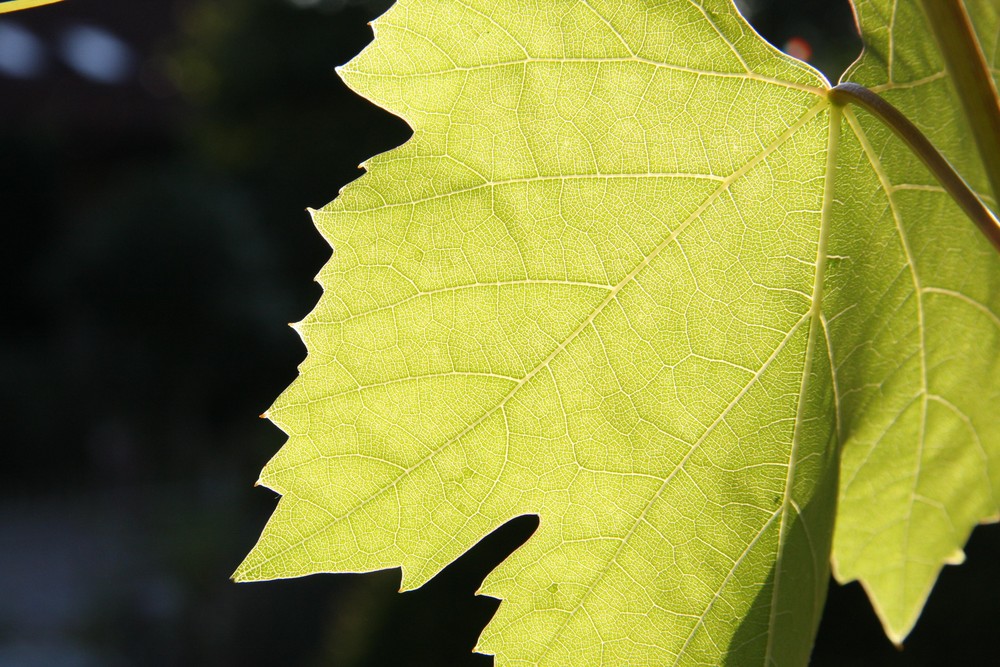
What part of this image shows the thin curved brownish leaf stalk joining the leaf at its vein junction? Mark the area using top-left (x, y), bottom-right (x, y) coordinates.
top-left (828, 83), bottom-right (1000, 252)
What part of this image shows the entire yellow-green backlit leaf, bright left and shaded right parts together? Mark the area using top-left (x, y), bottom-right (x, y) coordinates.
top-left (235, 0), bottom-right (1000, 667)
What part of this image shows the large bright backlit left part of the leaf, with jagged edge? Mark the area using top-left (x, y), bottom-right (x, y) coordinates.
top-left (238, 3), bottom-right (835, 664)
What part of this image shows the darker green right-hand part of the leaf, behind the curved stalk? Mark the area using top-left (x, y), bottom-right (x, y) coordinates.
top-left (824, 0), bottom-right (1000, 643)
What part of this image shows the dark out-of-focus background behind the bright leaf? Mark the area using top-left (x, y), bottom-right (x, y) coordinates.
top-left (0, 0), bottom-right (1000, 667)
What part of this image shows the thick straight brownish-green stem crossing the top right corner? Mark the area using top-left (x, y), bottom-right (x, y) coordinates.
top-left (921, 0), bottom-right (1000, 206)
